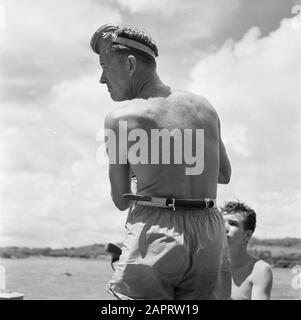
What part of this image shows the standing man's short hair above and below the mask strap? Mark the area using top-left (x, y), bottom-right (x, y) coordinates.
top-left (112, 28), bottom-right (158, 66)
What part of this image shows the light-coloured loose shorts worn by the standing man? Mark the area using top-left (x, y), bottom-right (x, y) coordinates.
top-left (107, 206), bottom-right (225, 300)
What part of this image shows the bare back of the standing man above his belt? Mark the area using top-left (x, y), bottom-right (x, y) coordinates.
top-left (111, 91), bottom-right (220, 199)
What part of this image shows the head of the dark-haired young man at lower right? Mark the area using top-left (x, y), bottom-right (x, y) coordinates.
top-left (221, 201), bottom-right (256, 246)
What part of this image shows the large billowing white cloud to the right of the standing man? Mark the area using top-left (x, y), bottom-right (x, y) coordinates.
top-left (190, 19), bottom-right (301, 237)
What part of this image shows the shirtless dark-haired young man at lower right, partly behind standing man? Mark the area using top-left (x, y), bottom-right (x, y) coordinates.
top-left (221, 201), bottom-right (273, 300)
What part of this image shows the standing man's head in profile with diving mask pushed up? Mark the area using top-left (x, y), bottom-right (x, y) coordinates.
top-left (91, 25), bottom-right (158, 101)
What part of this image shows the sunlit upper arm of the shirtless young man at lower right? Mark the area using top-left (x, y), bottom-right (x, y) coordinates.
top-left (251, 264), bottom-right (273, 300)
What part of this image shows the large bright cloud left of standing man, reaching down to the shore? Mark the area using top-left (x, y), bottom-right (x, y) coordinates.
top-left (0, 70), bottom-right (130, 246)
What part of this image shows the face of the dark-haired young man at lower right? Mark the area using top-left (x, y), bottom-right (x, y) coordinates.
top-left (224, 213), bottom-right (252, 247)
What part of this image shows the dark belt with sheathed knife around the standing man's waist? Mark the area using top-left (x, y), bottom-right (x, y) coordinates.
top-left (122, 193), bottom-right (217, 211)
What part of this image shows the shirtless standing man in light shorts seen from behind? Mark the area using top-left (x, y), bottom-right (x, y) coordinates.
top-left (91, 25), bottom-right (231, 300)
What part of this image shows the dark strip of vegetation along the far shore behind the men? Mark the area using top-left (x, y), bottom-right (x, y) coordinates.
top-left (0, 238), bottom-right (301, 268)
